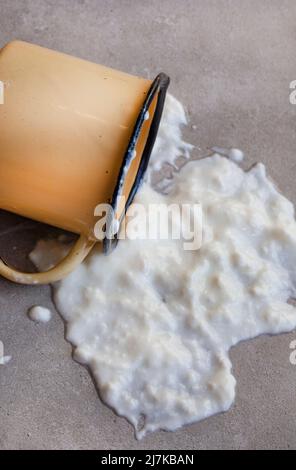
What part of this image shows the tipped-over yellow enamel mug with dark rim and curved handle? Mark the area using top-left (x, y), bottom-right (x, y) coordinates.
top-left (0, 41), bottom-right (169, 284)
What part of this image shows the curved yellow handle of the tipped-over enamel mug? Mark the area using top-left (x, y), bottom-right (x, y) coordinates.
top-left (0, 235), bottom-right (96, 284)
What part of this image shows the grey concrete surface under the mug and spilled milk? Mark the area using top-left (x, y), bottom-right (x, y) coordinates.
top-left (0, 0), bottom-right (296, 449)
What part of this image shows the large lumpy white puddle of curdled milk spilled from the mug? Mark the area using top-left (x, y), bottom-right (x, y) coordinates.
top-left (32, 94), bottom-right (296, 438)
